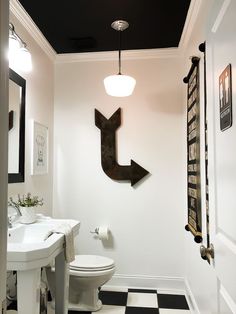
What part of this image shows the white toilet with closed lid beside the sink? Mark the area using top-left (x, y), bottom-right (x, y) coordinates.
top-left (47, 255), bottom-right (115, 311)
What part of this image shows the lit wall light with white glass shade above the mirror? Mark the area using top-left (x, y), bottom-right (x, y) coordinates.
top-left (9, 23), bottom-right (32, 72)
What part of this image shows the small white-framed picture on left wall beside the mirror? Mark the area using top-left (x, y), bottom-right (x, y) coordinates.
top-left (31, 120), bottom-right (48, 175)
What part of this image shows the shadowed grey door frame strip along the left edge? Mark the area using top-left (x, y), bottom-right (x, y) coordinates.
top-left (0, 0), bottom-right (9, 313)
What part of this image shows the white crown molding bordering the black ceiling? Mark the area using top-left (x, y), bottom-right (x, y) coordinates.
top-left (10, 0), bottom-right (197, 63)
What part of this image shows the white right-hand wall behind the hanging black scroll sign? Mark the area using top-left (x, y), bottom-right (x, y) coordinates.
top-left (184, 1), bottom-right (217, 314)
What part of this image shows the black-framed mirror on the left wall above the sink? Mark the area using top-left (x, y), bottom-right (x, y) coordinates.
top-left (8, 69), bottom-right (26, 183)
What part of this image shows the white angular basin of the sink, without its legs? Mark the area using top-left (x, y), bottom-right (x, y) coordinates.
top-left (7, 218), bottom-right (80, 270)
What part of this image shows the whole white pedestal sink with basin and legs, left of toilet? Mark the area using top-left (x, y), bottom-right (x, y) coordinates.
top-left (7, 216), bottom-right (80, 314)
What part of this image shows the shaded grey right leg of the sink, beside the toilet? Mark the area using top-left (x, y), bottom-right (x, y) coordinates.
top-left (55, 251), bottom-right (69, 314)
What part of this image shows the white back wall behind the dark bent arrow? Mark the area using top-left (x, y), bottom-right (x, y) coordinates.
top-left (53, 57), bottom-right (186, 284)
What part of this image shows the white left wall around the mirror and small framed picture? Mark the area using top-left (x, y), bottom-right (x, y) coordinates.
top-left (8, 13), bottom-right (54, 214)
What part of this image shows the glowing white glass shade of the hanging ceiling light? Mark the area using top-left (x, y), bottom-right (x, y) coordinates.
top-left (104, 74), bottom-right (136, 97)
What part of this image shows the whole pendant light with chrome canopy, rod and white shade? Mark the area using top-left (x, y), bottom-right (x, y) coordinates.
top-left (104, 20), bottom-right (136, 97)
